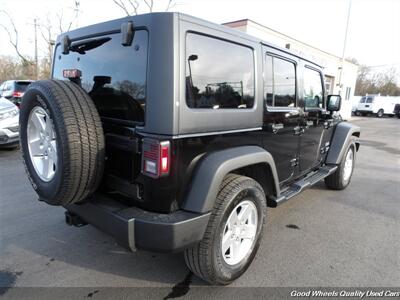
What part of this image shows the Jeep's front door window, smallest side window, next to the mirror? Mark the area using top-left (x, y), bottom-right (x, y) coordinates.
top-left (304, 67), bottom-right (324, 108)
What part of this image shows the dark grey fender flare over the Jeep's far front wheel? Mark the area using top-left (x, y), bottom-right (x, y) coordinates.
top-left (325, 122), bottom-right (361, 165)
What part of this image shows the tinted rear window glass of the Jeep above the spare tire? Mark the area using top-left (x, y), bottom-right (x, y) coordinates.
top-left (53, 30), bottom-right (148, 123)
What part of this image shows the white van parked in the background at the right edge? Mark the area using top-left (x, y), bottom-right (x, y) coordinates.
top-left (354, 95), bottom-right (400, 118)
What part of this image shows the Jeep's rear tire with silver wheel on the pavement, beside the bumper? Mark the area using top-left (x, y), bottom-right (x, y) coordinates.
top-left (184, 174), bottom-right (267, 285)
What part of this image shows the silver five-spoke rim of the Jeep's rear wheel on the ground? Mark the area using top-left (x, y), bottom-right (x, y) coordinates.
top-left (221, 200), bottom-right (258, 265)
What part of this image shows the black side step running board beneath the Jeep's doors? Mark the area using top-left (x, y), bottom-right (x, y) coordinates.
top-left (271, 165), bottom-right (338, 206)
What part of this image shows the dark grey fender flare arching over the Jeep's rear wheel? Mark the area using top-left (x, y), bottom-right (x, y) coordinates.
top-left (182, 146), bottom-right (280, 213)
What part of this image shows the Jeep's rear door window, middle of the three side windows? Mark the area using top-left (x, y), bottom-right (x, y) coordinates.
top-left (264, 55), bottom-right (296, 107)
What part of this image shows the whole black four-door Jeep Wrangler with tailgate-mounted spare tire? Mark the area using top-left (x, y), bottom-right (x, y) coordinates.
top-left (20, 13), bottom-right (360, 284)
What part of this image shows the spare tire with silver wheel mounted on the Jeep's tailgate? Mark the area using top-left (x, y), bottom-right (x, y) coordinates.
top-left (20, 80), bottom-right (105, 205)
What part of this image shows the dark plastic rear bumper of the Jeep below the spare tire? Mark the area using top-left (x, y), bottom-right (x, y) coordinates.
top-left (65, 196), bottom-right (210, 252)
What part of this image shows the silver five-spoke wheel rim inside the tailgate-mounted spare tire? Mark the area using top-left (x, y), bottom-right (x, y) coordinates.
top-left (27, 106), bottom-right (57, 182)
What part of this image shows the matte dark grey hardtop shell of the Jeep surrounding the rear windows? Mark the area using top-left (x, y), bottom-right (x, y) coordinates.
top-left (54, 12), bottom-right (319, 136)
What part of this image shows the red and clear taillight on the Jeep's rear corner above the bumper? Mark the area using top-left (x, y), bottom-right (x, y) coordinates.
top-left (142, 138), bottom-right (171, 178)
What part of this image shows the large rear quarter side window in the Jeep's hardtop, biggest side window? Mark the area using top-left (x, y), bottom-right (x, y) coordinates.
top-left (186, 33), bottom-right (255, 109)
